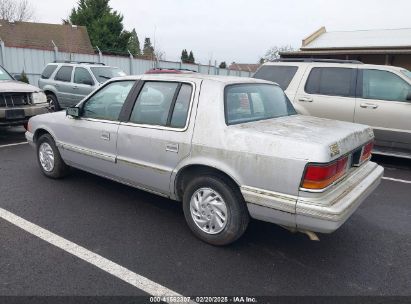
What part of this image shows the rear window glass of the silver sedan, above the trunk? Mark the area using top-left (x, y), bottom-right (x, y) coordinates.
top-left (225, 84), bottom-right (297, 125)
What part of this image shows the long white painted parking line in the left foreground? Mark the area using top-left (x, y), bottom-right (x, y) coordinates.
top-left (0, 208), bottom-right (190, 302)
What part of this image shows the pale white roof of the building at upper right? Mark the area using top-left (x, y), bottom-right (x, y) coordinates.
top-left (301, 27), bottom-right (411, 51)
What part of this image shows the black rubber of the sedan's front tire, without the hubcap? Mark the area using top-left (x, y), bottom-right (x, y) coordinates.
top-left (36, 134), bottom-right (70, 179)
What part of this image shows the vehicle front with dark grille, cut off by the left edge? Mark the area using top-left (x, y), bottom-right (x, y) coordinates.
top-left (0, 66), bottom-right (48, 126)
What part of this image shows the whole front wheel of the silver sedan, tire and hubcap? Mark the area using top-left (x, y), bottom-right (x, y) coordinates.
top-left (37, 134), bottom-right (70, 179)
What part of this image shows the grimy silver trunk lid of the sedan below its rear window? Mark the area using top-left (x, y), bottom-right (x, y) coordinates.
top-left (233, 115), bottom-right (374, 162)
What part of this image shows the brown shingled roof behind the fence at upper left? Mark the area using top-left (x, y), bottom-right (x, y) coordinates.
top-left (0, 20), bottom-right (94, 54)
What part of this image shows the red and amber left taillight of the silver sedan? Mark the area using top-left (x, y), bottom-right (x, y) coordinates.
top-left (302, 156), bottom-right (348, 190)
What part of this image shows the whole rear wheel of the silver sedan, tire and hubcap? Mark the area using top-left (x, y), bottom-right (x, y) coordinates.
top-left (183, 175), bottom-right (249, 245)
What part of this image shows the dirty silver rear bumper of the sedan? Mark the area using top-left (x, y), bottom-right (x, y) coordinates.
top-left (241, 162), bottom-right (384, 233)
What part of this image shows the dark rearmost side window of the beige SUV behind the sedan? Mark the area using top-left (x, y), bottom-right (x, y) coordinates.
top-left (254, 65), bottom-right (298, 90)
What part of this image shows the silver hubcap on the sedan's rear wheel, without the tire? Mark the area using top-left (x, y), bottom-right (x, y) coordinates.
top-left (190, 188), bottom-right (227, 234)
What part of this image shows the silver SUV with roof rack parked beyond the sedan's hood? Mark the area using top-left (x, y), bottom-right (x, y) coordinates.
top-left (39, 61), bottom-right (126, 111)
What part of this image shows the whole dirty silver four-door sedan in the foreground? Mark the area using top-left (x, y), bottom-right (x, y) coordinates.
top-left (26, 74), bottom-right (383, 245)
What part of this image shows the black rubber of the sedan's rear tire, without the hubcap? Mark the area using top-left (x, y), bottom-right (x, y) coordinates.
top-left (183, 175), bottom-right (250, 246)
